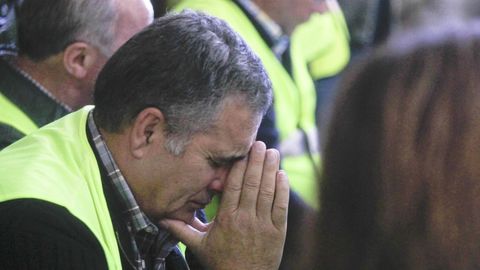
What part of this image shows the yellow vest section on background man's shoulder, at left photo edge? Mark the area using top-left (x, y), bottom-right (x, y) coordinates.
top-left (0, 93), bottom-right (38, 134)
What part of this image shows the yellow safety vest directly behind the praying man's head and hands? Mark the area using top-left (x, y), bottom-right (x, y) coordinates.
top-left (173, 0), bottom-right (320, 207)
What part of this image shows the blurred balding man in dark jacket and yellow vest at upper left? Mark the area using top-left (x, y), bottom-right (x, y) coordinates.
top-left (0, 0), bottom-right (153, 149)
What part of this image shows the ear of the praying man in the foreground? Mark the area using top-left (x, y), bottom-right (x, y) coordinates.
top-left (129, 107), bottom-right (166, 158)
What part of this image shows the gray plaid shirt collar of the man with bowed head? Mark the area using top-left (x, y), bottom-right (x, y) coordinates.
top-left (88, 111), bottom-right (178, 270)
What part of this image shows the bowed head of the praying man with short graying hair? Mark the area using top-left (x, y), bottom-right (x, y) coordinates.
top-left (94, 11), bottom-right (272, 223)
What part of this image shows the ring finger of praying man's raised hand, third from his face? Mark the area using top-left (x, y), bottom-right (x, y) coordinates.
top-left (257, 149), bottom-right (280, 219)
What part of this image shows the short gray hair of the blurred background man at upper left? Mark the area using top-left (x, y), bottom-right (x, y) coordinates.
top-left (18, 0), bottom-right (118, 60)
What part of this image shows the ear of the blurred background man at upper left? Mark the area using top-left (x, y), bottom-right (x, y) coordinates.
top-left (63, 42), bottom-right (100, 79)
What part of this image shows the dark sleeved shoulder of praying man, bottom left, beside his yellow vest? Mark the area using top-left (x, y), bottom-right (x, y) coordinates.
top-left (0, 199), bottom-right (107, 269)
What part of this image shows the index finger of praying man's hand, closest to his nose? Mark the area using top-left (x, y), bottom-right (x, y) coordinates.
top-left (217, 155), bottom-right (248, 215)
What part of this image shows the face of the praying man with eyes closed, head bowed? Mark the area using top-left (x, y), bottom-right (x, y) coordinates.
top-left (134, 100), bottom-right (261, 223)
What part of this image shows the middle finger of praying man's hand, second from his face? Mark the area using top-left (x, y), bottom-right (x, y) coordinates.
top-left (239, 142), bottom-right (266, 214)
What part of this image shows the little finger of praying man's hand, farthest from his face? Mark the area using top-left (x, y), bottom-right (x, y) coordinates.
top-left (272, 171), bottom-right (290, 230)
